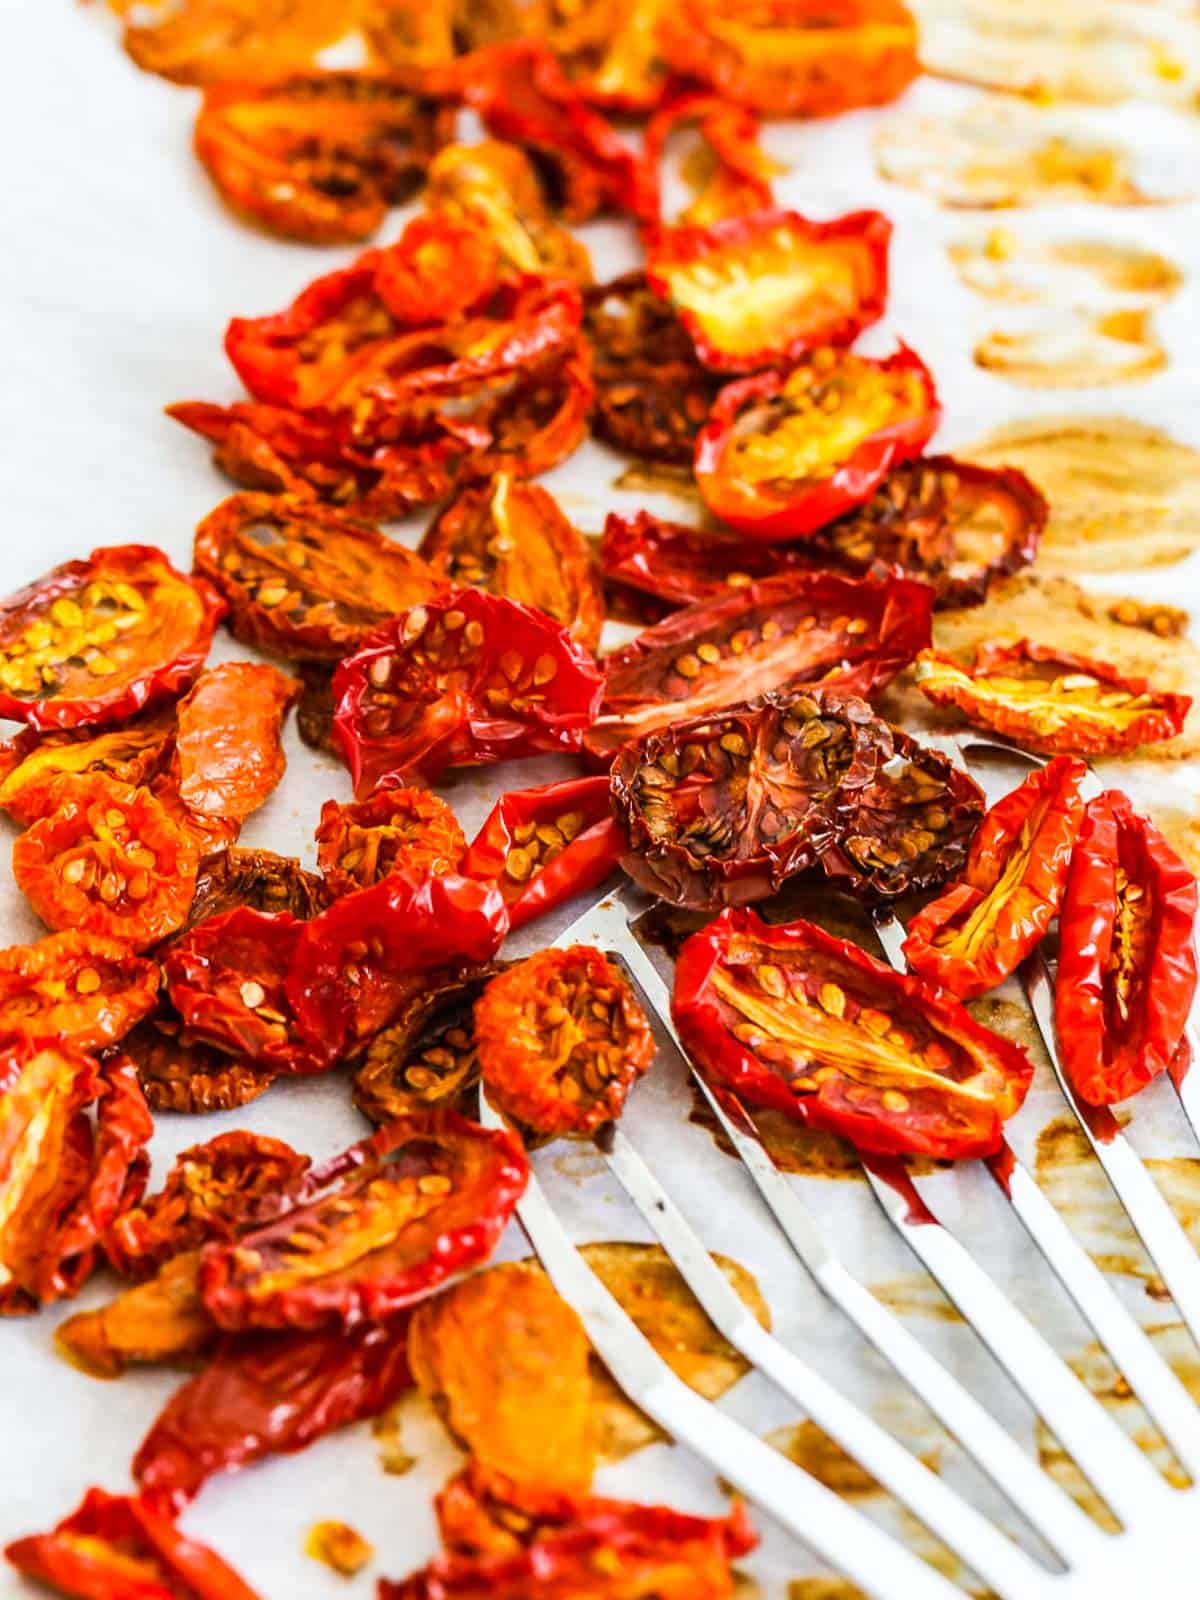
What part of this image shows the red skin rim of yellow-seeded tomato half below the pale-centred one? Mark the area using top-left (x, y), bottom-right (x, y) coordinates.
top-left (694, 346), bottom-right (941, 541)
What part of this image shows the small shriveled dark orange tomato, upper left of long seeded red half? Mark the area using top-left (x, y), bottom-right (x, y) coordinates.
top-left (102, 1130), bottom-right (310, 1278)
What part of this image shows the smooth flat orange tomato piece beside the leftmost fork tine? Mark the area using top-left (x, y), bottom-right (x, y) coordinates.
top-left (408, 1262), bottom-right (597, 1498)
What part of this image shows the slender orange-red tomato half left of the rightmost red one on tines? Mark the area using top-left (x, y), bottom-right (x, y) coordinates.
top-left (904, 755), bottom-right (1088, 1000)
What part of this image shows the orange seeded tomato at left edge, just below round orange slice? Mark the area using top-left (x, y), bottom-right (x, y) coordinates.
top-left (0, 931), bottom-right (158, 1050)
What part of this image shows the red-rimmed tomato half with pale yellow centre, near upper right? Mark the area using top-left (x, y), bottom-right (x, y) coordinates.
top-left (646, 211), bottom-right (891, 373)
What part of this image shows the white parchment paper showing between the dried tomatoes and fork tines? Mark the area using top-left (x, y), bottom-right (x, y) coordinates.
top-left (0, 0), bottom-right (1200, 1600)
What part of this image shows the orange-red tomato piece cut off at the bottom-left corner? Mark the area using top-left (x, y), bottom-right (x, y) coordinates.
top-left (5, 1490), bottom-right (258, 1600)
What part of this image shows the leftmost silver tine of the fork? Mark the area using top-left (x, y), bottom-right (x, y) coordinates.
top-left (480, 1094), bottom-right (966, 1600)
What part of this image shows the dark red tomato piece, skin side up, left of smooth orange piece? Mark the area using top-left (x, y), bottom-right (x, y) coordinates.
top-left (133, 1318), bottom-right (411, 1510)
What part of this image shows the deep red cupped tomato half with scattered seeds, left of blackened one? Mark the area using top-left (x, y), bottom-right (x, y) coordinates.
top-left (333, 587), bottom-right (602, 795)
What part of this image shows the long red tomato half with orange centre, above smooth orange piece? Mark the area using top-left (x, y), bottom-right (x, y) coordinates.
top-left (202, 1110), bottom-right (528, 1328)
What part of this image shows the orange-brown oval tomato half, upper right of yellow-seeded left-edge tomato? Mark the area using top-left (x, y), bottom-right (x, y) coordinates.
top-left (192, 494), bottom-right (435, 659)
